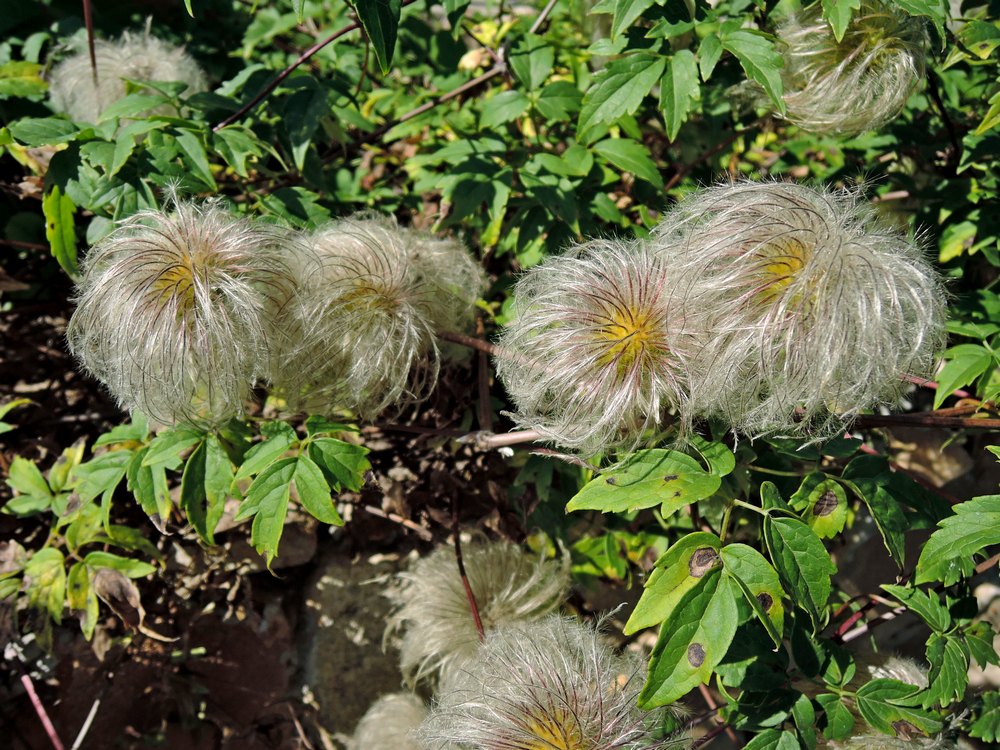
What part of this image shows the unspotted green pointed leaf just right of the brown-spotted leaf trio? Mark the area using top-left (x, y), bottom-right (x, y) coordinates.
top-left (764, 515), bottom-right (837, 630)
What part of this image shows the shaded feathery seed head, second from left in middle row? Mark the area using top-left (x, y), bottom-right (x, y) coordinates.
top-left (272, 215), bottom-right (482, 416)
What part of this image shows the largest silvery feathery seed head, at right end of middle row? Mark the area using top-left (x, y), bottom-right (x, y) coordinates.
top-left (652, 183), bottom-right (945, 436)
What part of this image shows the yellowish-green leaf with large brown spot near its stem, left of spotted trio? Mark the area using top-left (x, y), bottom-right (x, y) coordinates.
top-left (625, 531), bottom-right (722, 635)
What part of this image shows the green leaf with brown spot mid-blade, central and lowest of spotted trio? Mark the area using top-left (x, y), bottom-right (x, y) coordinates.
top-left (639, 569), bottom-right (739, 708)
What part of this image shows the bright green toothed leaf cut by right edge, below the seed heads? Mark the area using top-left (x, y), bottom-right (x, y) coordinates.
top-left (915, 495), bottom-right (1000, 586)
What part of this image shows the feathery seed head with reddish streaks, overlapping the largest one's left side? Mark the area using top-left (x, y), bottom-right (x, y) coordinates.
top-left (496, 240), bottom-right (692, 454)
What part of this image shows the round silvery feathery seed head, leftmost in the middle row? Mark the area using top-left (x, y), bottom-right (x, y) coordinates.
top-left (66, 201), bottom-right (294, 424)
